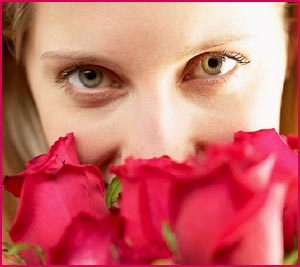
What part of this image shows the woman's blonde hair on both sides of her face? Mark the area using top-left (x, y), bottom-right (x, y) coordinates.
top-left (2, 2), bottom-right (298, 230)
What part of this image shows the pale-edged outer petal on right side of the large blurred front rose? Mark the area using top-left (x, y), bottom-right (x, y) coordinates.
top-left (214, 184), bottom-right (286, 265)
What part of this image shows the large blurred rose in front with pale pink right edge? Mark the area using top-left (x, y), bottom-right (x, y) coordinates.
top-left (171, 153), bottom-right (285, 265)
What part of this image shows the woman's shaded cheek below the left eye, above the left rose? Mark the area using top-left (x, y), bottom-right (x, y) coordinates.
top-left (31, 91), bottom-right (126, 166)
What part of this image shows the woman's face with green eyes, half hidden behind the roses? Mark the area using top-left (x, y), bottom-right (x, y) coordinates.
top-left (25, 3), bottom-right (286, 180)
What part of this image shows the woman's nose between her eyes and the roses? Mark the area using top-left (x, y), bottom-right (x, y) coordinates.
top-left (120, 80), bottom-right (195, 162)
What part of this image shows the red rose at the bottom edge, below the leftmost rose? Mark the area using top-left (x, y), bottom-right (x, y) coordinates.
top-left (47, 213), bottom-right (123, 265)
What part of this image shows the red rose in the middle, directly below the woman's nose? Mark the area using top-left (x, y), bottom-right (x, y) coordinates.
top-left (110, 157), bottom-right (179, 264)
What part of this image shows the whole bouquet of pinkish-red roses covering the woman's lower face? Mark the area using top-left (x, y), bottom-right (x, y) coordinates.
top-left (3, 129), bottom-right (298, 265)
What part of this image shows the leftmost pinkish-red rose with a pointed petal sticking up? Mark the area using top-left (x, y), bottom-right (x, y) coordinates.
top-left (4, 134), bottom-right (113, 263)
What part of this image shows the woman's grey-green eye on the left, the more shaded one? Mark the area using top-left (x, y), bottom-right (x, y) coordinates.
top-left (68, 67), bottom-right (114, 89)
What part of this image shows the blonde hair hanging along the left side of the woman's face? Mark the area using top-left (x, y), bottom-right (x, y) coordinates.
top-left (2, 3), bottom-right (47, 231)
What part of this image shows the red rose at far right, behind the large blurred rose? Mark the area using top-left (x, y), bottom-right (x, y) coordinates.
top-left (235, 130), bottom-right (298, 255)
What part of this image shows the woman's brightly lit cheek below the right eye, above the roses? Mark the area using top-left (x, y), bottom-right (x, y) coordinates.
top-left (192, 80), bottom-right (282, 146)
